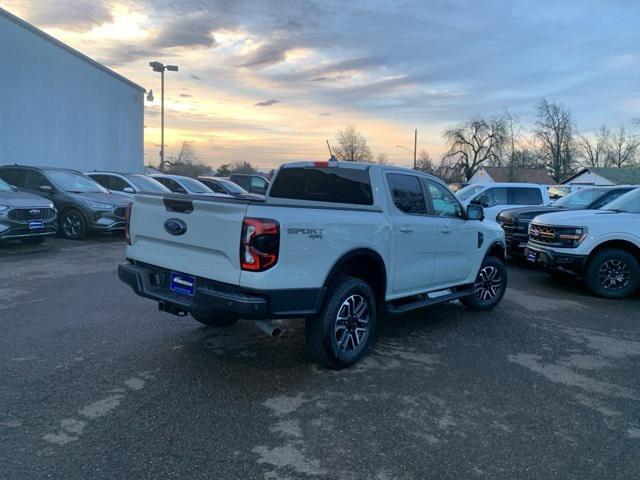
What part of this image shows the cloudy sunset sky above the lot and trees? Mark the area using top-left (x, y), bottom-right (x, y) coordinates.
top-left (0, 0), bottom-right (640, 170)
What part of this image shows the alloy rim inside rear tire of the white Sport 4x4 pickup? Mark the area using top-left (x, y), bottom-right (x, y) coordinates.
top-left (334, 295), bottom-right (370, 352)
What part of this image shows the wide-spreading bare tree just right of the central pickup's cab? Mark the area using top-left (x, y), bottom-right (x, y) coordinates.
top-left (443, 118), bottom-right (507, 180)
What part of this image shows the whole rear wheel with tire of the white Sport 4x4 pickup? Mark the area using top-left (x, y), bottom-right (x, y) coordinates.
top-left (305, 276), bottom-right (376, 369)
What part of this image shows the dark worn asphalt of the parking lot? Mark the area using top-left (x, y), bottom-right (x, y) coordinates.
top-left (0, 237), bottom-right (640, 480)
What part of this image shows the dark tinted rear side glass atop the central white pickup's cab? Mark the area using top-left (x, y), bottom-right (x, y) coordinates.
top-left (269, 167), bottom-right (373, 205)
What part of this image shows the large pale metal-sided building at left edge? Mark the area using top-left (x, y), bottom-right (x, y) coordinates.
top-left (0, 8), bottom-right (144, 172)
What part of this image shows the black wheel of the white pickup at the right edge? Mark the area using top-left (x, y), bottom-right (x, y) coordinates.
top-left (584, 248), bottom-right (640, 298)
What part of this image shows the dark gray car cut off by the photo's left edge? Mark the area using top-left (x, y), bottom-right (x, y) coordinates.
top-left (0, 176), bottom-right (57, 245)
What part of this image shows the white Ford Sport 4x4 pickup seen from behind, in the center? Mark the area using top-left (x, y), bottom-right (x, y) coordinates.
top-left (118, 160), bottom-right (507, 368)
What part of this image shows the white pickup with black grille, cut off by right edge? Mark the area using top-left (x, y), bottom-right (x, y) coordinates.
top-left (525, 188), bottom-right (640, 298)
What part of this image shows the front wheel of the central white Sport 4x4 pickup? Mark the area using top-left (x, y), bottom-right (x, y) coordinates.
top-left (460, 256), bottom-right (507, 311)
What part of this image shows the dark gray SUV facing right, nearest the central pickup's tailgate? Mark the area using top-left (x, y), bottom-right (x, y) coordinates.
top-left (0, 165), bottom-right (129, 240)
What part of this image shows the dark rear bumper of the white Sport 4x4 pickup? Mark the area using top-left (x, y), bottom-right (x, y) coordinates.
top-left (118, 263), bottom-right (325, 320)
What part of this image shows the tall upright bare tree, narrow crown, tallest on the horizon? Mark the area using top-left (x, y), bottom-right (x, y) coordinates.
top-left (534, 98), bottom-right (574, 183)
